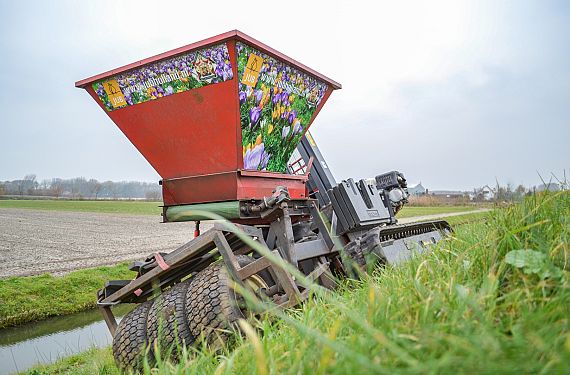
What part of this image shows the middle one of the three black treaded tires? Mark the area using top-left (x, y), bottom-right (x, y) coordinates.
top-left (147, 280), bottom-right (195, 359)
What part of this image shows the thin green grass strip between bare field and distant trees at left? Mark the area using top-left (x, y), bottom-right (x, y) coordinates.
top-left (0, 199), bottom-right (162, 216)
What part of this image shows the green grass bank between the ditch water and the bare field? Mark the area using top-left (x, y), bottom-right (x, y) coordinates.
top-left (0, 263), bottom-right (134, 328)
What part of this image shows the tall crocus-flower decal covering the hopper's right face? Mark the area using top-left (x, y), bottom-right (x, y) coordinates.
top-left (236, 42), bottom-right (328, 173)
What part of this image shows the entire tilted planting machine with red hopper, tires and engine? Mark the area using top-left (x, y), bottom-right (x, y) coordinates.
top-left (76, 31), bottom-right (451, 368)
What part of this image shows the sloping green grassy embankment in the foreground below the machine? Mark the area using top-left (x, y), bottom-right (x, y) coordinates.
top-left (21, 193), bottom-right (570, 375)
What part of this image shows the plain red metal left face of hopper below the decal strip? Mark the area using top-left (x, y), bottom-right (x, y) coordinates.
top-left (87, 80), bottom-right (235, 178)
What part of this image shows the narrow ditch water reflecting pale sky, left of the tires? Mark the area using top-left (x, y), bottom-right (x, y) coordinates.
top-left (0, 305), bottom-right (134, 375)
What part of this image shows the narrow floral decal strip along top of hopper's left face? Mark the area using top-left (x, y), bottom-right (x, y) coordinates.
top-left (92, 43), bottom-right (233, 111)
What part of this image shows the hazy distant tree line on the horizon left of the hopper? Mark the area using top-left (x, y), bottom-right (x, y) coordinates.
top-left (0, 174), bottom-right (162, 200)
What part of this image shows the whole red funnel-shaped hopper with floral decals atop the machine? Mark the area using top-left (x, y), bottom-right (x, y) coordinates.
top-left (75, 31), bottom-right (340, 206)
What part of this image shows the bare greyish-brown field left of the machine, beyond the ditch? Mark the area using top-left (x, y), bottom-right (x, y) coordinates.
top-left (0, 208), bottom-right (206, 278)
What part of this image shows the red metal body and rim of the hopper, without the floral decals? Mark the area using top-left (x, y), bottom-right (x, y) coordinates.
top-left (75, 31), bottom-right (341, 206)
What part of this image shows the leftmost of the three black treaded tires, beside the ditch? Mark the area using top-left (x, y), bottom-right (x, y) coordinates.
top-left (113, 301), bottom-right (152, 371)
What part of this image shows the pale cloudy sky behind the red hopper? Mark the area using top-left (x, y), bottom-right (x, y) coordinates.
top-left (0, 0), bottom-right (570, 190)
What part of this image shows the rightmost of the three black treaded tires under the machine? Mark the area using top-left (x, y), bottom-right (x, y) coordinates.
top-left (186, 256), bottom-right (267, 344)
